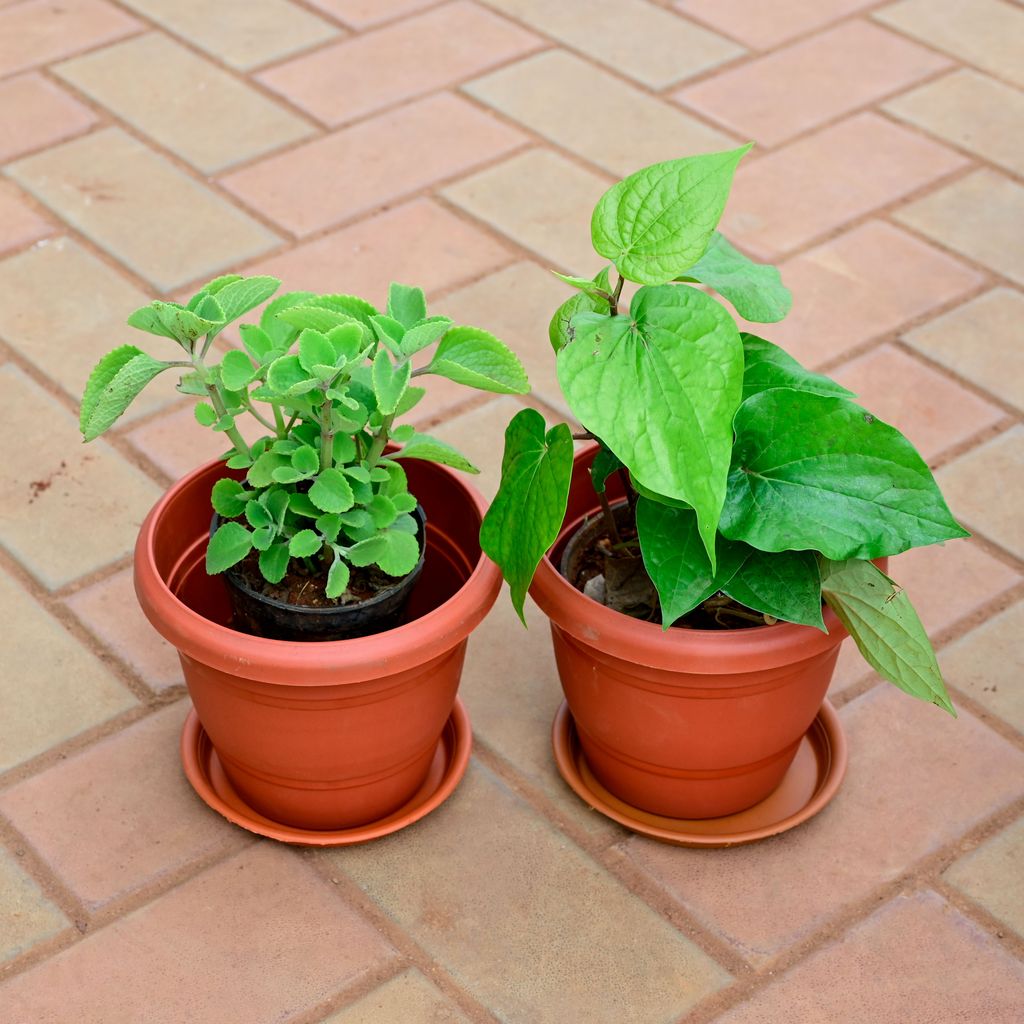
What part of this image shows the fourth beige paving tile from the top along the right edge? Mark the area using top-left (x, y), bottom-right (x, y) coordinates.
top-left (903, 288), bottom-right (1024, 411)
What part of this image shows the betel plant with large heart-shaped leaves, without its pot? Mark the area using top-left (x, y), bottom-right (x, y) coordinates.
top-left (481, 145), bottom-right (967, 713)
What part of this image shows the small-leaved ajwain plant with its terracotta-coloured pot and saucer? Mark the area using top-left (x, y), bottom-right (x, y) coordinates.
top-left (81, 274), bottom-right (528, 843)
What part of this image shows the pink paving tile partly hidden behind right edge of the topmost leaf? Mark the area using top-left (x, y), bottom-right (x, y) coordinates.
top-left (722, 113), bottom-right (966, 259)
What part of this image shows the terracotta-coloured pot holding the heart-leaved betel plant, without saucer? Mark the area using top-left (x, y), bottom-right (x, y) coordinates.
top-left (530, 449), bottom-right (847, 818)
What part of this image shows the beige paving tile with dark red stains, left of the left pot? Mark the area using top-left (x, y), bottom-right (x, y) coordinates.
top-left (0, 365), bottom-right (160, 588)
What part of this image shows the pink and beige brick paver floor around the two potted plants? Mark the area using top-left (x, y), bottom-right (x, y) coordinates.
top-left (0, 0), bottom-right (1024, 1024)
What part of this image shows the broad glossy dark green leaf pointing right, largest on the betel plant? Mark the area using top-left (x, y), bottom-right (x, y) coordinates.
top-left (721, 388), bottom-right (967, 559)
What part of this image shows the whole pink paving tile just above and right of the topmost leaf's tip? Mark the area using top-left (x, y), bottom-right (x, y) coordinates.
top-left (675, 22), bottom-right (949, 145)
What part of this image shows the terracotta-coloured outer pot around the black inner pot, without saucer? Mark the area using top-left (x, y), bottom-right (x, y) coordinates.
top-left (135, 460), bottom-right (501, 829)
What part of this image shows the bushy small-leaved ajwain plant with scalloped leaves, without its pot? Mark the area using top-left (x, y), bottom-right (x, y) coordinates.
top-left (80, 274), bottom-right (529, 599)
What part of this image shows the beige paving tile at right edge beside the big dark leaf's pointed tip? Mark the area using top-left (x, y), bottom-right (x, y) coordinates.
top-left (936, 426), bottom-right (1024, 558)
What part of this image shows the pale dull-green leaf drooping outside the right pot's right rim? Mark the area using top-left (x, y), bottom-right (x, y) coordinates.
top-left (821, 558), bottom-right (956, 718)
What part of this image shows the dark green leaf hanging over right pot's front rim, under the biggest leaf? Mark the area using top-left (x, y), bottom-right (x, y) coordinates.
top-left (722, 548), bottom-right (825, 632)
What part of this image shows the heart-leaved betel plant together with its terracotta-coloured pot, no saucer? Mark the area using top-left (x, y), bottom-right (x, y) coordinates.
top-left (480, 146), bottom-right (966, 823)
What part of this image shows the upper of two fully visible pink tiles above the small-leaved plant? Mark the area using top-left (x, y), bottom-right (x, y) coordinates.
top-left (258, 0), bottom-right (542, 126)
